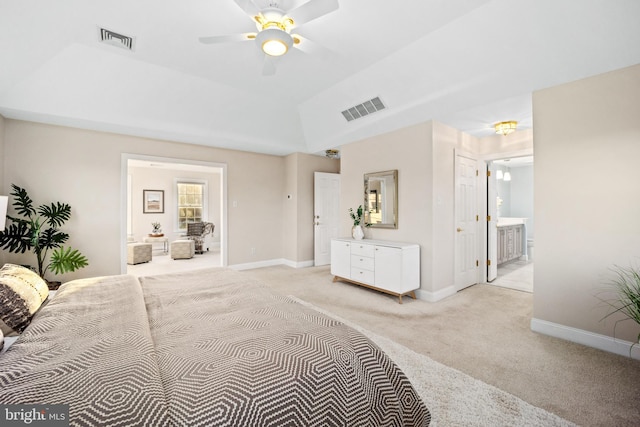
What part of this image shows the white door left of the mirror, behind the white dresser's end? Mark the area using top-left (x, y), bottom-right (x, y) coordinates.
top-left (313, 172), bottom-right (340, 265)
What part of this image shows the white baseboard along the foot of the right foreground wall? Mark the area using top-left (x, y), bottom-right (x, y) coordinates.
top-left (531, 318), bottom-right (640, 360)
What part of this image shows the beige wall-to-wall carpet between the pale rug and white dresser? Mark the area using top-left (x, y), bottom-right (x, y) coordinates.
top-left (243, 266), bottom-right (640, 427)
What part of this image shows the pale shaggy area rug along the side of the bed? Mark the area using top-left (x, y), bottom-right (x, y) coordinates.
top-left (289, 295), bottom-right (575, 427)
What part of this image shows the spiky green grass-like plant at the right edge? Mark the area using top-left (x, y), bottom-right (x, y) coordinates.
top-left (600, 266), bottom-right (640, 354)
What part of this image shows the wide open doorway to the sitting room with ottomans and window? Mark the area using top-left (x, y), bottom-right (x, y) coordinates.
top-left (121, 154), bottom-right (227, 275)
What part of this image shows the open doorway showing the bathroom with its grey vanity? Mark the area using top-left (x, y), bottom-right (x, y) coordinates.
top-left (487, 156), bottom-right (535, 292)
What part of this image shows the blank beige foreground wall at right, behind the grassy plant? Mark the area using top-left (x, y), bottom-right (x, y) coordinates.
top-left (533, 65), bottom-right (640, 344)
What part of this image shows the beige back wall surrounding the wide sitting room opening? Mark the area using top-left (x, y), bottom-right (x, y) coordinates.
top-left (0, 120), bottom-right (285, 280)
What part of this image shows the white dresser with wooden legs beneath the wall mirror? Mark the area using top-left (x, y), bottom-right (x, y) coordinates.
top-left (331, 238), bottom-right (420, 304)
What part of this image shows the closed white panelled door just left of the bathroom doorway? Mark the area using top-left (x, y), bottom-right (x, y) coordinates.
top-left (455, 154), bottom-right (479, 290)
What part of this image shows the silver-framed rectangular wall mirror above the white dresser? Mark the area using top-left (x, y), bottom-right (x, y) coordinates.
top-left (364, 169), bottom-right (398, 228)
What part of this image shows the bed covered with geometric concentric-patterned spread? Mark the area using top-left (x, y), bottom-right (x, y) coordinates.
top-left (0, 268), bottom-right (430, 426)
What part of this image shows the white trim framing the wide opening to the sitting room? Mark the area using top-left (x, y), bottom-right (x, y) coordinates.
top-left (120, 153), bottom-right (228, 274)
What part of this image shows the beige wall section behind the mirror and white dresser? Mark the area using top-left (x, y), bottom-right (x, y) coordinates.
top-left (340, 122), bottom-right (444, 292)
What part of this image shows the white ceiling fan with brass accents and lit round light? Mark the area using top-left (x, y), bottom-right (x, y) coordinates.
top-left (199, 0), bottom-right (339, 75)
